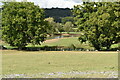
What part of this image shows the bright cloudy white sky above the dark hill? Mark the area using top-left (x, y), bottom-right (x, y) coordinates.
top-left (0, 0), bottom-right (82, 8)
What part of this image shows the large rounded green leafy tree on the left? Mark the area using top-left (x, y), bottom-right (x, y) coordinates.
top-left (2, 2), bottom-right (48, 49)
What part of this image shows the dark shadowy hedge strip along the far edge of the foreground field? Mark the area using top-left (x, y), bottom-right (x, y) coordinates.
top-left (0, 45), bottom-right (119, 51)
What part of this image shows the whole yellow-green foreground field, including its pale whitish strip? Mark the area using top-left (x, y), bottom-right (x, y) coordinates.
top-left (2, 50), bottom-right (118, 78)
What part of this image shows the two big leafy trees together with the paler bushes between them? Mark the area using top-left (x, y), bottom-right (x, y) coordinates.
top-left (2, 2), bottom-right (120, 50)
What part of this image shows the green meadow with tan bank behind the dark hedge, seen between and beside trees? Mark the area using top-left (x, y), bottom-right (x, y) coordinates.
top-left (0, 37), bottom-right (120, 50)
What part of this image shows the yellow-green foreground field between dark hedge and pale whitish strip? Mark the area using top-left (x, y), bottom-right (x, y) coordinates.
top-left (2, 50), bottom-right (118, 77)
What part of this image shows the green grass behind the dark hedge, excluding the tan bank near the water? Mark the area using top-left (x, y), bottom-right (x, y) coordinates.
top-left (0, 37), bottom-right (120, 49)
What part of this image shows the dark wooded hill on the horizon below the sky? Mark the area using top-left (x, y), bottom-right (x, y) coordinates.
top-left (44, 8), bottom-right (72, 22)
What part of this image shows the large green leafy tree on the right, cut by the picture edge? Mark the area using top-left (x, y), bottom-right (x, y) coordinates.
top-left (73, 2), bottom-right (120, 50)
